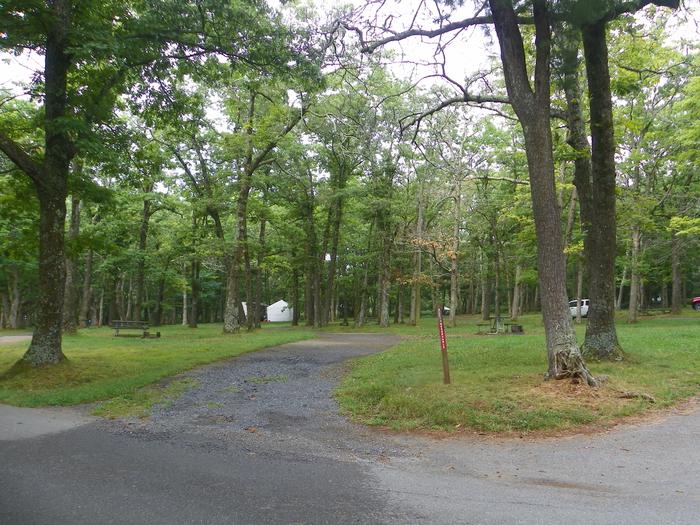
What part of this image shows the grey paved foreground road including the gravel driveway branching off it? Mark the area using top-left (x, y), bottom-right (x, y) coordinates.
top-left (0, 335), bottom-right (700, 524)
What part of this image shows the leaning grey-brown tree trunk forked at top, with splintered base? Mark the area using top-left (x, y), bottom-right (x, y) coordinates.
top-left (489, 0), bottom-right (596, 385)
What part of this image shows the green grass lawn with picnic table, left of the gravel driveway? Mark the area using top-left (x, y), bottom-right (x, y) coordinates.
top-left (0, 325), bottom-right (314, 406)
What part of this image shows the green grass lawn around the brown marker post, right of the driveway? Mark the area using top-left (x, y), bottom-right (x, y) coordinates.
top-left (336, 312), bottom-right (700, 433)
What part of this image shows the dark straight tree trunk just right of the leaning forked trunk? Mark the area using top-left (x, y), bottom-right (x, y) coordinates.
top-left (579, 22), bottom-right (623, 360)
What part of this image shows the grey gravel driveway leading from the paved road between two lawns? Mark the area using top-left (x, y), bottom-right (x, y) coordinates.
top-left (105, 334), bottom-right (408, 460)
